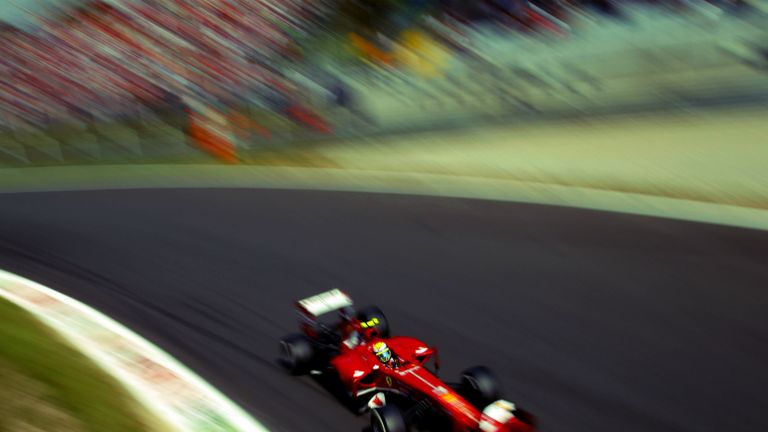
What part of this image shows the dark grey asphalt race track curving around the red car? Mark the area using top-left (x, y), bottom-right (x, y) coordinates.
top-left (0, 190), bottom-right (768, 432)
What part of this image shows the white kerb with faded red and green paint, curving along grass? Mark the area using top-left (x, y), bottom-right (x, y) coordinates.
top-left (0, 269), bottom-right (268, 432)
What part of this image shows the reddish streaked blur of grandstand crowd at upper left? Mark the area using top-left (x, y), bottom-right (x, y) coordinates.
top-left (0, 0), bottom-right (328, 131)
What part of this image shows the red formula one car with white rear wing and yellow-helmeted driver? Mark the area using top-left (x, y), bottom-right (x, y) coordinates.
top-left (280, 289), bottom-right (535, 432)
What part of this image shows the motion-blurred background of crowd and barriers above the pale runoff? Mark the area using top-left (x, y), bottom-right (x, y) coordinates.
top-left (0, 0), bottom-right (768, 166)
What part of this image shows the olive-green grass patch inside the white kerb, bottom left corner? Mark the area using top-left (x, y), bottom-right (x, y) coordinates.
top-left (0, 298), bottom-right (159, 432)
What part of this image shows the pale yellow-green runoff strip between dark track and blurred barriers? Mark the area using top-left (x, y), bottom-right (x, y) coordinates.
top-left (0, 106), bottom-right (768, 229)
